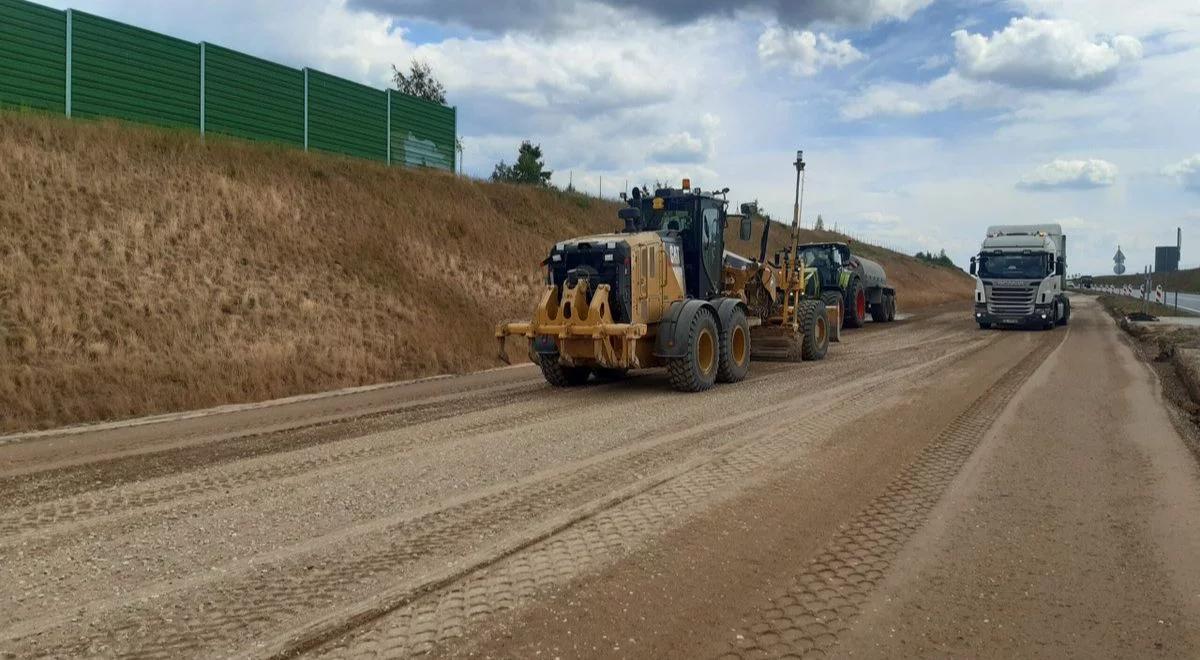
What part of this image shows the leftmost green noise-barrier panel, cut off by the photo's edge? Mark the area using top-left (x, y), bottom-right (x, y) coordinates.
top-left (0, 0), bottom-right (67, 113)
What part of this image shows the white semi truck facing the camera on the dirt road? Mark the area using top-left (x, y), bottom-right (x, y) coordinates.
top-left (971, 224), bottom-right (1070, 330)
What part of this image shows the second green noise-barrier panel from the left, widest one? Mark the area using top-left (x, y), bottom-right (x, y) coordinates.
top-left (72, 12), bottom-right (200, 128)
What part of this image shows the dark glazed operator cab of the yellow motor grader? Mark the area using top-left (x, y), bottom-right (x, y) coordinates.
top-left (620, 179), bottom-right (728, 300)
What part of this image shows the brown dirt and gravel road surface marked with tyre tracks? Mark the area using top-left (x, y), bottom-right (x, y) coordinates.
top-left (0, 301), bottom-right (1200, 659)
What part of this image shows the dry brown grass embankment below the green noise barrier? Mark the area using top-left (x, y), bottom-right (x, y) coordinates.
top-left (0, 113), bottom-right (970, 431)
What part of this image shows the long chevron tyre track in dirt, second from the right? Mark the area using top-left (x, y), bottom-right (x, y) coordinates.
top-left (302, 328), bottom-right (1003, 658)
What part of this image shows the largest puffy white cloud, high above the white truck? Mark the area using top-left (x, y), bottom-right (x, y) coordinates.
top-left (953, 17), bottom-right (1142, 89)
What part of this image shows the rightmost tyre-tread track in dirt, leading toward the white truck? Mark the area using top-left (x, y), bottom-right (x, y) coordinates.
top-left (714, 330), bottom-right (1069, 660)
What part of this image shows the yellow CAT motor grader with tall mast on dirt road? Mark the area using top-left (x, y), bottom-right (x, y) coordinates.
top-left (496, 155), bottom-right (841, 391)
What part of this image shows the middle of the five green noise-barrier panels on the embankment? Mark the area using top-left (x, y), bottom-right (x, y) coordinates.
top-left (204, 43), bottom-right (304, 146)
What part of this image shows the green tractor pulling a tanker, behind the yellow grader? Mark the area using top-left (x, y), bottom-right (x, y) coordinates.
top-left (796, 242), bottom-right (896, 328)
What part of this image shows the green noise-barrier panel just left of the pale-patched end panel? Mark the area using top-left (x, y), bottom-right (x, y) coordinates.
top-left (308, 70), bottom-right (388, 161)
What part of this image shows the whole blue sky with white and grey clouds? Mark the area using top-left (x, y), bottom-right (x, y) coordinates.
top-left (43, 0), bottom-right (1200, 274)
